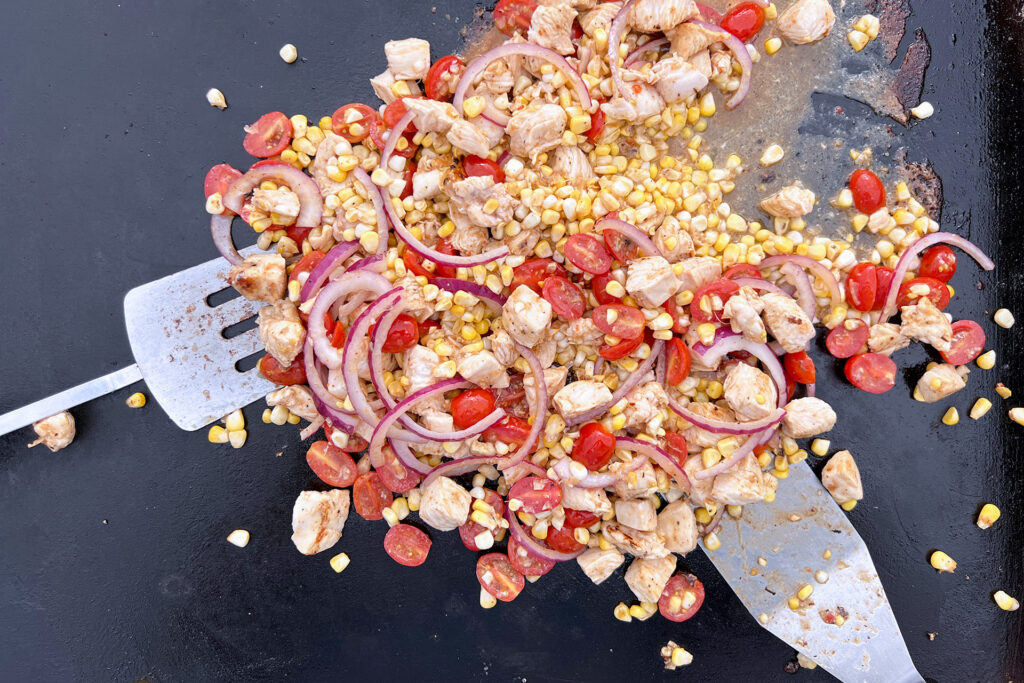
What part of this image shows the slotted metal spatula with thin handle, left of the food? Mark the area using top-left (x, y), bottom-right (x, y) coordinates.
top-left (0, 248), bottom-right (274, 434)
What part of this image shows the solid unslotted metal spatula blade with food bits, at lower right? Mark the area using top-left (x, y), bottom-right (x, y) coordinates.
top-left (706, 463), bottom-right (924, 683)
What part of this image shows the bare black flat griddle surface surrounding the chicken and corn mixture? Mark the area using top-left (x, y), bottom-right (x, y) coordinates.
top-left (0, 0), bottom-right (1024, 682)
